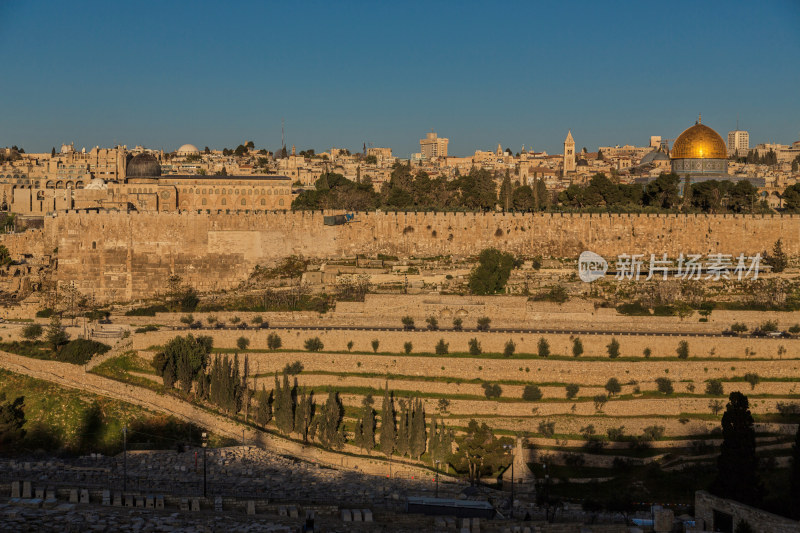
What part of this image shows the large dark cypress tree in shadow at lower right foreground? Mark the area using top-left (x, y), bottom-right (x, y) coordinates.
top-left (711, 392), bottom-right (762, 505)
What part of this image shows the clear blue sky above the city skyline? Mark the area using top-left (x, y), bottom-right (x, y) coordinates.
top-left (0, 0), bottom-right (800, 156)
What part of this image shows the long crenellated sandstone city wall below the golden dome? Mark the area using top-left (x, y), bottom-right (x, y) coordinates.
top-left (40, 212), bottom-right (800, 301)
